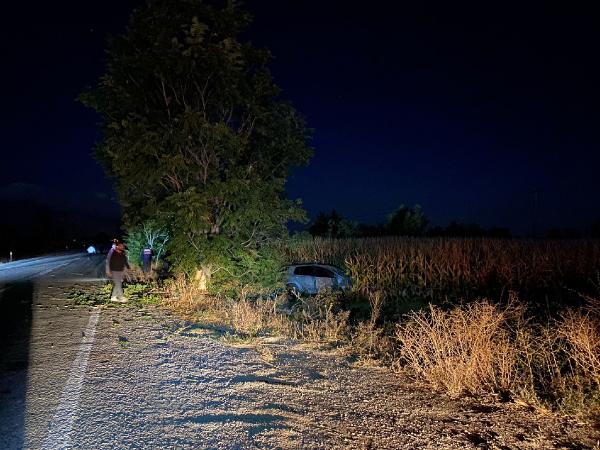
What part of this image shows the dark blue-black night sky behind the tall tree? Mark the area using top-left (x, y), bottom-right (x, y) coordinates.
top-left (0, 0), bottom-right (600, 233)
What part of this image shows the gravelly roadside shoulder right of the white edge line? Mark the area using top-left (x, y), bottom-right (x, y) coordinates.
top-left (73, 286), bottom-right (600, 449)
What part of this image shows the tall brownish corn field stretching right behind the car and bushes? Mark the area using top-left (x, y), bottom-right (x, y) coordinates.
top-left (283, 237), bottom-right (600, 312)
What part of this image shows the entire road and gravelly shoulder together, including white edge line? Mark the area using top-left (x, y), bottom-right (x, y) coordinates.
top-left (0, 255), bottom-right (599, 450)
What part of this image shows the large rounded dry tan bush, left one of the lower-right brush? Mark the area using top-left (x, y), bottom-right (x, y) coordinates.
top-left (396, 301), bottom-right (521, 396)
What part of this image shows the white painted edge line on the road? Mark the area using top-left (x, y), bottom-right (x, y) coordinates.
top-left (42, 309), bottom-right (100, 450)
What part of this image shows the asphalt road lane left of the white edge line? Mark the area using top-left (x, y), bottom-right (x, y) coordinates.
top-left (0, 253), bottom-right (104, 449)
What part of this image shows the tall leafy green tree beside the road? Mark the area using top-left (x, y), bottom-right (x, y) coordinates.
top-left (81, 0), bottom-right (312, 286)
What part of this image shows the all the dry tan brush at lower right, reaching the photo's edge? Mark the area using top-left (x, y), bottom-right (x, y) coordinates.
top-left (396, 301), bottom-right (600, 421)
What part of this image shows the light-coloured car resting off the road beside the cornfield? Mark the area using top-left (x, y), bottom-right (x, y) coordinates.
top-left (286, 263), bottom-right (352, 295)
